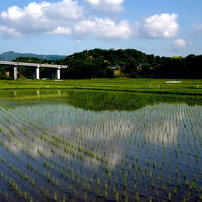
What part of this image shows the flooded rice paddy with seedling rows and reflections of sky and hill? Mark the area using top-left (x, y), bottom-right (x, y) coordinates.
top-left (0, 90), bottom-right (202, 202)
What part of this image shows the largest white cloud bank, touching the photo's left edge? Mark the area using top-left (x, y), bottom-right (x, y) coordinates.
top-left (0, 0), bottom-right (83, 37)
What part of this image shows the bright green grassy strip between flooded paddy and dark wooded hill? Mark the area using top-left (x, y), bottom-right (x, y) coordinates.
top-left (0, 78), bottom-right (202, 95)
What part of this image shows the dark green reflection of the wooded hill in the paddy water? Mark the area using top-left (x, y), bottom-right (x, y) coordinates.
top-left (68, 91), bottom-right (202, 111)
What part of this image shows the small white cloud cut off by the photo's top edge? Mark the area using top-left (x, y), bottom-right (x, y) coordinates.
top-left (86, 0), bottom-right (124, 13)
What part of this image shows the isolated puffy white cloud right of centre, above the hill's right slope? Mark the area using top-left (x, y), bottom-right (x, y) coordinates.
top-left (139, 13), bottom-right (179, 38)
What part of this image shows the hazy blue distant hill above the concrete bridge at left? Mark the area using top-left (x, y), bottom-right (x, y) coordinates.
top-left (0, 51), bottom-right (67, 61)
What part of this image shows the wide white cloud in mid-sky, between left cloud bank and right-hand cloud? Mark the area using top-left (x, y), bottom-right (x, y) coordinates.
top-left (75, 17), bottom-right (132, 40)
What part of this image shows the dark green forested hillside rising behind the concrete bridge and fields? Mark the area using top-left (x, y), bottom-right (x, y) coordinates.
top-left (0, 49), bottom-right (202, 79)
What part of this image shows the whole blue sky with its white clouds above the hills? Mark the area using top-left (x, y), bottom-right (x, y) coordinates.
top-left (0, 0), bottom-right (202, 57)
